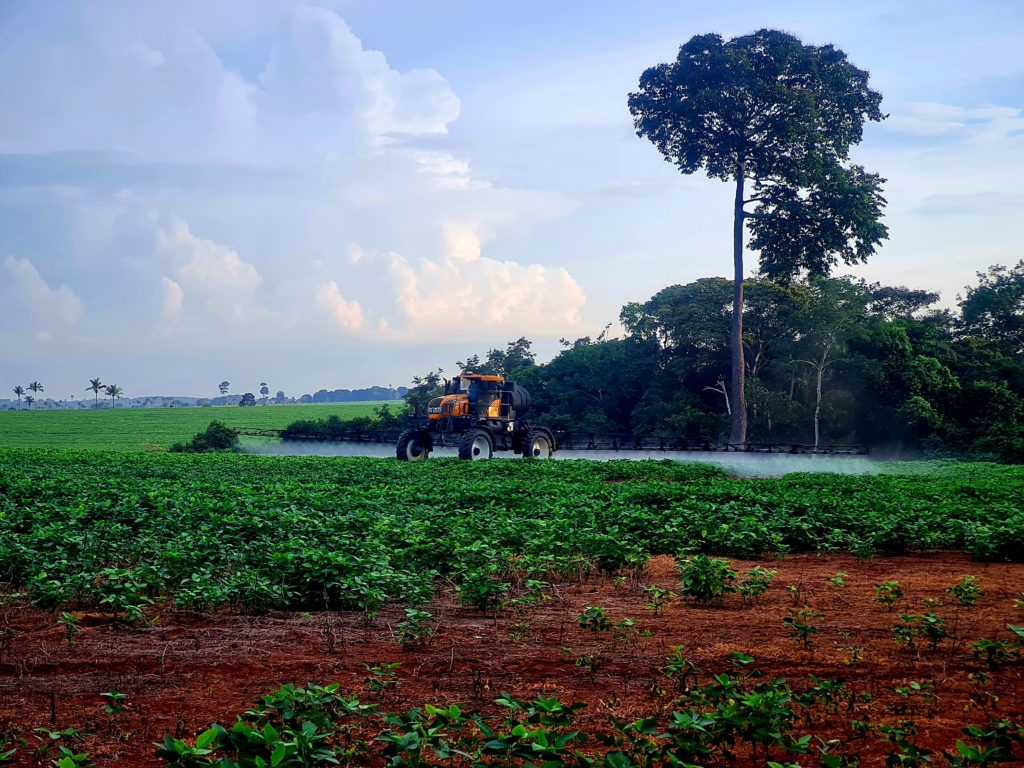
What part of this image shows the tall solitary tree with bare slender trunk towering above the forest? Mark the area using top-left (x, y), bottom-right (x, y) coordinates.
top-left (629, 30), bottom-right (887, 442)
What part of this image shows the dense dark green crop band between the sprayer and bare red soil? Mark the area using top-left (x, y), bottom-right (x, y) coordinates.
top-left (0, 450), bottom-right (1024, 616)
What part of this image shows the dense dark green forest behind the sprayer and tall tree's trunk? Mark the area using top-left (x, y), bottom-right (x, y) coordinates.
top-left (407, 261), bottom-right (1024, 462)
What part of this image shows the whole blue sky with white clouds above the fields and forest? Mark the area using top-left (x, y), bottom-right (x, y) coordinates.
top-left (0, 0), bottom-right (1024, 397)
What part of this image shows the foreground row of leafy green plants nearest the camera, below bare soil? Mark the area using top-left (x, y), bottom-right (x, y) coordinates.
top-left (14, 653), bottom-right (1024, 768)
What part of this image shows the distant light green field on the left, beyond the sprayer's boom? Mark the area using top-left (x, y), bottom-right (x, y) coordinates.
top-left (0, 400), bottom-right (404, 451)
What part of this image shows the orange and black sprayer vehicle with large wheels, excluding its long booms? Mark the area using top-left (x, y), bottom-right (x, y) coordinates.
top-left (396, 373), bottom-right (555, 461)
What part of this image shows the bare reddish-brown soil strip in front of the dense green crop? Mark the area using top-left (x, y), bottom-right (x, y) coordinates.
top-left (0, 553), bottom-right (1024, 767)
